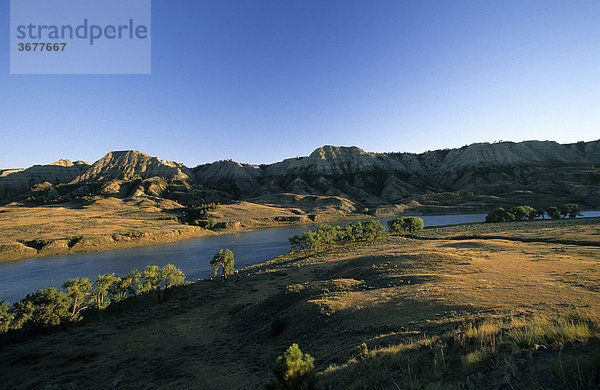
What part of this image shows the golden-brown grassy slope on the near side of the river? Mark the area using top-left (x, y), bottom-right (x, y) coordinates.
top-left (0, 219), bottom-right (600, 389)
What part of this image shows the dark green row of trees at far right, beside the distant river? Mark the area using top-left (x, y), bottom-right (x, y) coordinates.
top-left (485, 203), bottom-right (581, 222)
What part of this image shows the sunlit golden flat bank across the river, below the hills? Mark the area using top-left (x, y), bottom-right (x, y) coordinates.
top-left (0, 198), bottom-right (371, 261)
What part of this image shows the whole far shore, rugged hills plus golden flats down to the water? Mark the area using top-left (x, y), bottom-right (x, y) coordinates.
top-left (0, 141), bottom-right (600, 261)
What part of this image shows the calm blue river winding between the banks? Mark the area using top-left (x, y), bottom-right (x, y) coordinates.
top-left (0, 211), bottom-right (600, 302)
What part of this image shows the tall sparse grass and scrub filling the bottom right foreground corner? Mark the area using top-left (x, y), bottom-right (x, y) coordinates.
top-left (317, 312), bottom-right (600, 389)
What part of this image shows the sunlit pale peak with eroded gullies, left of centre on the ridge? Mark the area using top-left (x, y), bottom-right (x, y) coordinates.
top-left (72, 150), bottom-right (194, 184)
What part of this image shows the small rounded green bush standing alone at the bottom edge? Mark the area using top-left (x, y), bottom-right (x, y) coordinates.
top-left (273, 344), bottom-right (315, 390)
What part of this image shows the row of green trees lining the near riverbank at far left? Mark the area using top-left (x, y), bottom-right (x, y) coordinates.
top-left (0, 264), bottom-right (185, 335)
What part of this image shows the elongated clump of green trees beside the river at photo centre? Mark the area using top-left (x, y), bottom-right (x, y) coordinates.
top-left (289, 219), bottom-right (385, 252)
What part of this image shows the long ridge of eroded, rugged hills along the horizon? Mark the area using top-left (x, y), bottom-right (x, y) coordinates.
top-left (0, 140), bottom-right (600, 209)
